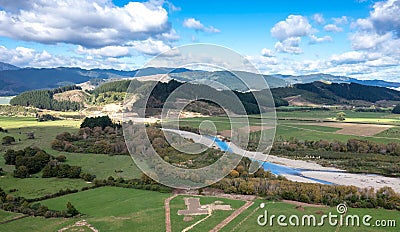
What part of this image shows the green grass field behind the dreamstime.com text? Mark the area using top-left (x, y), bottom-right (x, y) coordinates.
top-left (221, 200), bottom-right (400, 232)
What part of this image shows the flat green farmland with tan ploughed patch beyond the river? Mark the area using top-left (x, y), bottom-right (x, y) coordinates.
top-left (180, 111), bottom-right (400, 143)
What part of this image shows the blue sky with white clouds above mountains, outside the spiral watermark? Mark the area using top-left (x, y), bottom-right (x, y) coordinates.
top-left (0, 0), bottom-right (400, 81)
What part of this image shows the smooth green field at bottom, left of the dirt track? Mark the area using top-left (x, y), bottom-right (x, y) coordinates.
top-left (39, 187), bottom-right (171, 231)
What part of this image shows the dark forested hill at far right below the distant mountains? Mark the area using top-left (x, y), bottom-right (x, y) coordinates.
top-left (272, 81), bottom-right (400, 105)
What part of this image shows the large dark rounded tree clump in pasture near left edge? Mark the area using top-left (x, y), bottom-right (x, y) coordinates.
top-left (4, 147), bottom-right (52, 178)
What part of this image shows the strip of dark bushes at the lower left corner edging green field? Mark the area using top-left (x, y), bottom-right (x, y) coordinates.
top-left (0, 188), bottom-right (80, 218)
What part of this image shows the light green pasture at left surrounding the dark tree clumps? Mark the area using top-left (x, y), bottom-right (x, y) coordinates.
top-left (0, 117), bottom-right (141, 183)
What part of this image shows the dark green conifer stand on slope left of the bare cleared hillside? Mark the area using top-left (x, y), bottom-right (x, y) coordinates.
top-left (10, 86), bottom-right (81, 111)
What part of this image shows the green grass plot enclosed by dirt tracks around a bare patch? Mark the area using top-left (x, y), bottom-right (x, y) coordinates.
top-left (170, 196), bottom-right (244, 231)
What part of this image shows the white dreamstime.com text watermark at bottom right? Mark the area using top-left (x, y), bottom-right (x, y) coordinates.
top-left (257, 203), bottom-right (396, 227)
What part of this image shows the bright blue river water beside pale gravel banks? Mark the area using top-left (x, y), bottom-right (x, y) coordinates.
top-left (214, 137), bottom-right (333, 185)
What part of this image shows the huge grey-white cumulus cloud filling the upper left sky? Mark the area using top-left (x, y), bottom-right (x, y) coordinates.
top-left (0, 0), bottom-right (171, 48)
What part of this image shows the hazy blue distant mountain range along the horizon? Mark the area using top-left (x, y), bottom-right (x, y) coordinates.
top-left (0, 62), bottom-right (400, 96)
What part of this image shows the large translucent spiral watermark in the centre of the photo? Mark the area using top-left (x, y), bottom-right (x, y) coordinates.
top-left (123, 44), bottom-right (276, 189)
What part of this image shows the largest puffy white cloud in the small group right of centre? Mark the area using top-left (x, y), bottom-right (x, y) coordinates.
top-left (271, 15), bottom-right (314, 41)
